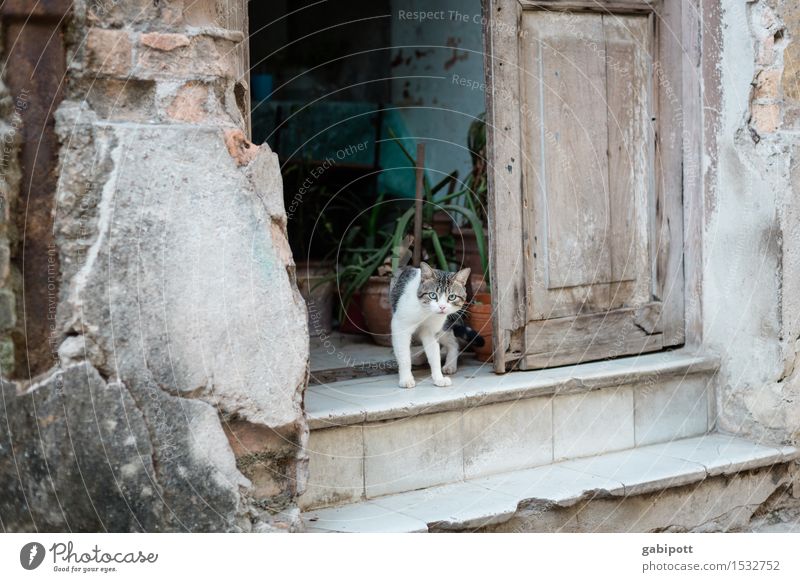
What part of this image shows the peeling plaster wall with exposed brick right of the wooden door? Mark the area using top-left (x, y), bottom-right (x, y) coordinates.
top-left (703, 0), bottom-right (800, 444)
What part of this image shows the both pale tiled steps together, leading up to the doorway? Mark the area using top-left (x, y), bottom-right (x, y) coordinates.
top-left (300, 351), bottom-right (794, 531)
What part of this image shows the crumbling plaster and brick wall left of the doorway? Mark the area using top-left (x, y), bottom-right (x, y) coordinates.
top-left (0, 0), bottom-right (308, 531)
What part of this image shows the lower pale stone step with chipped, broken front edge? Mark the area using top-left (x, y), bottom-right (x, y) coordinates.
top-left (303, 433), bottom-right (800, 532)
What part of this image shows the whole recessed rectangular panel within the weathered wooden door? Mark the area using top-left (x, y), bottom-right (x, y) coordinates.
top-left (520, 11), bottom-right (652, 320)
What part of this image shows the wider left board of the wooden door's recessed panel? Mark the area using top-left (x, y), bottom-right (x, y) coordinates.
top-left (532, 11), bottom-right (611, 289)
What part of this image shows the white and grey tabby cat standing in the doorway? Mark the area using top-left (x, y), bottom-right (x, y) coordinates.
top-left (389, 262), bottom-right (483, 388)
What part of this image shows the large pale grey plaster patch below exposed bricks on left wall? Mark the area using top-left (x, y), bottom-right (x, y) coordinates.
top-left (50, 115), bottom-right (308, 433)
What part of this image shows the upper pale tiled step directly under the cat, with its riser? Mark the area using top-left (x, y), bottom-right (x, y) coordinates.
top-left (300, 351), bottom-right (718, 510)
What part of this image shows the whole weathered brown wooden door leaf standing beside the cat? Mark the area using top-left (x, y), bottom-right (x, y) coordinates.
top-left (486, 0), bottom-right (684, 371)
